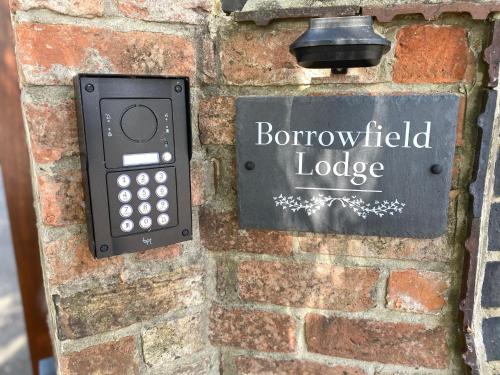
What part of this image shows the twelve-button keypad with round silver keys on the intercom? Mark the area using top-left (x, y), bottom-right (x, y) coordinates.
top-left (107, 167), bottom-right (177, 237)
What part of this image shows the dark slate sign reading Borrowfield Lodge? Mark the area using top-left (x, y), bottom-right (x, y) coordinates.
top-left (236, 95), bottom-right (460, 238)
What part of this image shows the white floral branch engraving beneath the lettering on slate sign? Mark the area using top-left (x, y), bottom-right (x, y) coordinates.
top-left (273, 194), bottom-right (405, 219)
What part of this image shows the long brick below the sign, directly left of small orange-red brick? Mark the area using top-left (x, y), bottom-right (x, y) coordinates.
top-left (238, 261), bottom-right (379, 311)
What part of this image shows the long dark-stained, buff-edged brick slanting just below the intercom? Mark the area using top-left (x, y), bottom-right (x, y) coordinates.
top-left (53, 267), bottom-right (204, 340)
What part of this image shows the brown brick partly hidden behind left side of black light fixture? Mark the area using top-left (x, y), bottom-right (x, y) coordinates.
top-left (220, 27), bottom-right (330, 86)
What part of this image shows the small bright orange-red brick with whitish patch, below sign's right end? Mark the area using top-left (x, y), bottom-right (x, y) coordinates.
top-left (387, 269), bottom-right (449, 313)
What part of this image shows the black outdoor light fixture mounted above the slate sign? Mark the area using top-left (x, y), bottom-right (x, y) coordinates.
top-left (290, 16), bottom-right (391, 74)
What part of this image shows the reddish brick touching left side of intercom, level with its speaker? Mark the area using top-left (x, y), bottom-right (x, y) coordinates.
top-left (24, 100), bottom-right (78, 163)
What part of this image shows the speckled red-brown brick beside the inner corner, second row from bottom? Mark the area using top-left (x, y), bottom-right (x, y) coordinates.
top-left (210, 307), bottom-right (295, 352)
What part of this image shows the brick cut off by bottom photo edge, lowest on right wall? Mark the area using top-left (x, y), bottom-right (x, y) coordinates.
top-left (235, 357), bottom-right (366, 375)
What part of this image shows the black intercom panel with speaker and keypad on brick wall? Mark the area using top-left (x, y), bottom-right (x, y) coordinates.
top-left (74, 74), bottom-right (192, 258)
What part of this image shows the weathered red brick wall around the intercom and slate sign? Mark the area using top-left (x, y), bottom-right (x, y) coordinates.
top-left (7, 0), bottom-right (494, 375)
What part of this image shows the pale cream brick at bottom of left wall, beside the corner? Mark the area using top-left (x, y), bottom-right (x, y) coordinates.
top-left (141, 315), bottom-right (204, 367)
